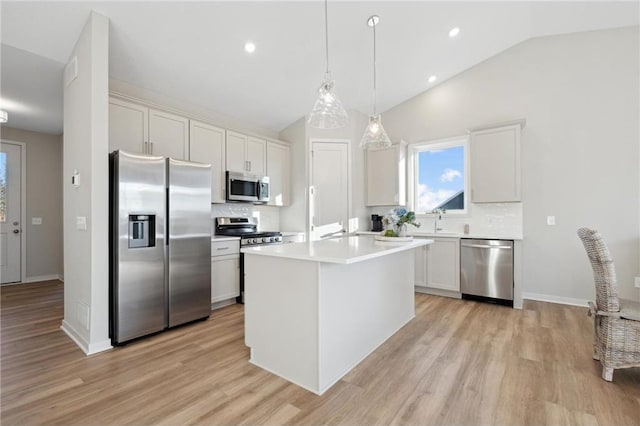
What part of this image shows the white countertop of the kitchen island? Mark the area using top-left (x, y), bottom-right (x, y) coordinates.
top-left (241, 235), bottom-right (433, 264)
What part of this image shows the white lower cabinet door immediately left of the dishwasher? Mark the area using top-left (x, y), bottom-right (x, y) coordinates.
top-left (427, 238), bottom-right (460, 291)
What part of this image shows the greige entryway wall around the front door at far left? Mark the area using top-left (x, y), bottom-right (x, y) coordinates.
top-left (1, 126), bottom-right (63, 282)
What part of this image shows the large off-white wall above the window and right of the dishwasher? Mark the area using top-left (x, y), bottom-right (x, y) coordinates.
top-left (383, 27), bottom-right (640, 302)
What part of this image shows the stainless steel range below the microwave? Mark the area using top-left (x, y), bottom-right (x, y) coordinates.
top-left (215, 217), bottom-right (282, 303)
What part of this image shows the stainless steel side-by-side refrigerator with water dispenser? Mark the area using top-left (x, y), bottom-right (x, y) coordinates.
top-left (109, 150), bottom-right (211, 345)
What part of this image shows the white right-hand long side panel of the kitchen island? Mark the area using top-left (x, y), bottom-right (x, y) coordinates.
top-left (319, 250), bottom-right (415, 393)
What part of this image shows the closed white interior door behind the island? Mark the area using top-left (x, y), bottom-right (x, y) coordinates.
top-left (309, 142), bottom-right (349, 240)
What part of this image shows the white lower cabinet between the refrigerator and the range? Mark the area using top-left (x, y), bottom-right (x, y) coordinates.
top-left (211, 240), bottom-right (240, 303)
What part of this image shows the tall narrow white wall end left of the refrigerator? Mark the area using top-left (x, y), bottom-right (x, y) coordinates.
top-left (62, 12), bottom-right (111, 354)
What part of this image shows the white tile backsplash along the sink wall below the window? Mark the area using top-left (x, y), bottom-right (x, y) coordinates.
top-left (367, 203), bottom-right (522, 238)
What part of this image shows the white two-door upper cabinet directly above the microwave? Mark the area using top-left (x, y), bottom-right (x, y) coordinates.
top-left (227, 130), bottom-right (267, 176)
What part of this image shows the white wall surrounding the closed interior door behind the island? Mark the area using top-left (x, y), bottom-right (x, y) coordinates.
top-left (279, 110), bottom-right (369, 239)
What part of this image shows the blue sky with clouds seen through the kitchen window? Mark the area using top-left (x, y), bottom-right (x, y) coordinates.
top-left (416, 146), bottom-right (465, 212)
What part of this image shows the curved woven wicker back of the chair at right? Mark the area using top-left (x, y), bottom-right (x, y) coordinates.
top-left (578, 228), bottom-right (620, 312)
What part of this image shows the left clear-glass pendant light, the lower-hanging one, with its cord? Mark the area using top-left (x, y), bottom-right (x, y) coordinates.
top-left (308, 0), bottom-right (349, 129)
